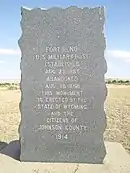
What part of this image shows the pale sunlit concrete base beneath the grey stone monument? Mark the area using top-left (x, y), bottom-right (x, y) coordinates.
top-left (0, 142), bottom-right (130, 173)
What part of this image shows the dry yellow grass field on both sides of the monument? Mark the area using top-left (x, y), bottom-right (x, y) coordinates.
top-left (0, 85), bottom-right (130, 152)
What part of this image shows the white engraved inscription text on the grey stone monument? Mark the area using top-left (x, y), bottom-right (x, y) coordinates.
top-left (35, 46), bottom-right (88, 140)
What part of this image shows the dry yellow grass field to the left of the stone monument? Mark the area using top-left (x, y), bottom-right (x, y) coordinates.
top-left (0, 88), bottom-right (20, 142)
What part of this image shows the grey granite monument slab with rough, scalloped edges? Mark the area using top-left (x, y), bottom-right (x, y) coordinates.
top-left (19, 7), bottom-right (107, 163)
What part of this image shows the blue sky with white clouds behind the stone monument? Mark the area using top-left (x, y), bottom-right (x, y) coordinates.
top-left (0, 0), bottom-right (130, 79)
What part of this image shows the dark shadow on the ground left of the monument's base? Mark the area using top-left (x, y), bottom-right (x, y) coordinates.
top-left (0, 140), bottom-right (20, 160)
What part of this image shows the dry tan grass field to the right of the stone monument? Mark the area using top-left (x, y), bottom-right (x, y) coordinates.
top-left (104, 85), bottom-right (130, 152)
